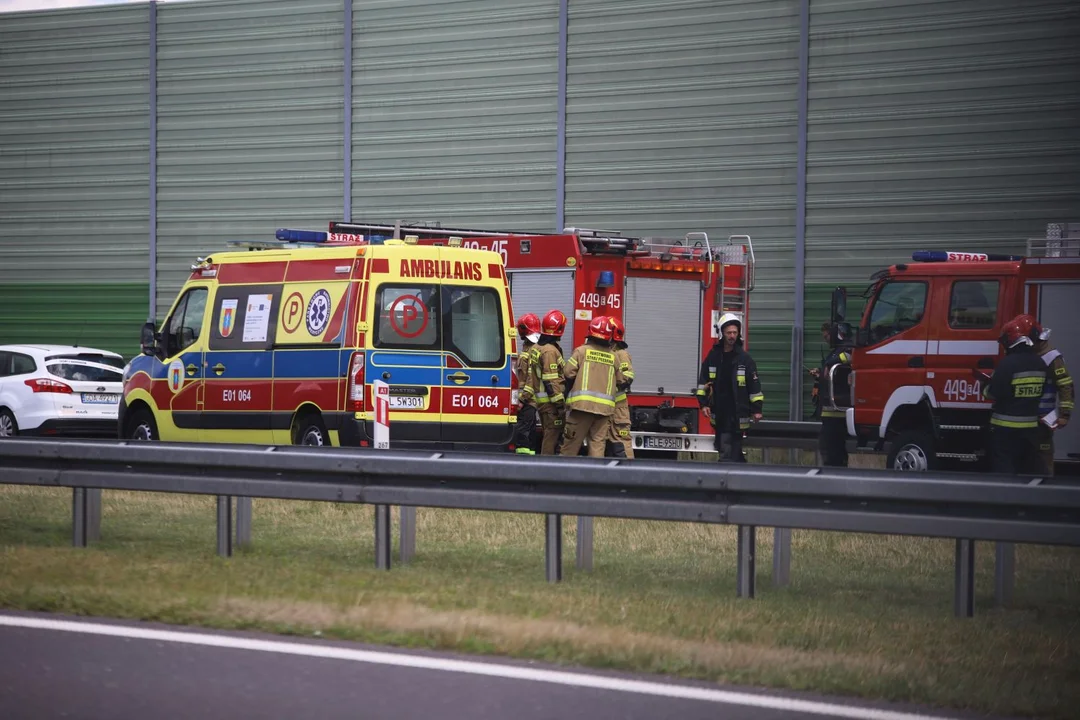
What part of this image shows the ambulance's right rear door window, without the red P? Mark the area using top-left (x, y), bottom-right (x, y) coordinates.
top-left (443, 287), bottom-right (507, 367)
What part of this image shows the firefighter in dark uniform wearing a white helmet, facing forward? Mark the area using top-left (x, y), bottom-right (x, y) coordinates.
top-left (697, 313), bottom-right (765, 462)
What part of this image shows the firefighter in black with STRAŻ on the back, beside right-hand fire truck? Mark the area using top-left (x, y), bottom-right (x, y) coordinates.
top-left (975, 316), bottom-right (1048, 475)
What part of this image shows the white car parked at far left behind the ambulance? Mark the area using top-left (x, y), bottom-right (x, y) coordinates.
top-left (0, 344), bottom-right (124, 438)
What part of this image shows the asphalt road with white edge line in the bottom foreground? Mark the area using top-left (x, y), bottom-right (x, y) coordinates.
top-left (0, 613), bottom-right (1006, 720)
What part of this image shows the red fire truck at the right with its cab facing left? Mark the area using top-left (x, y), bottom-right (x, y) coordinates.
top-left (824, 239), bottom-right (1080, 472)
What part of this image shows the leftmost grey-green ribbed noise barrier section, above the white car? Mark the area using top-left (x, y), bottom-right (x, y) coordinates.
top-left (0, 4), bottom-right (150, 284)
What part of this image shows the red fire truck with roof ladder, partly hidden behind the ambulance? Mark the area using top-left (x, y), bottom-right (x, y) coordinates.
top-left (329, 222), bottom-right (754, 456)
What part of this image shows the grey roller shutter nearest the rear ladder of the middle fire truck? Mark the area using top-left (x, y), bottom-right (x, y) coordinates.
top-left (623, 277), bottom-right (702, 395)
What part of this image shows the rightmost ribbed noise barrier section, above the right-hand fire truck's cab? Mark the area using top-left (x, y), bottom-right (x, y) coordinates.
top-left (807, 0), bottom-right (1080, 287)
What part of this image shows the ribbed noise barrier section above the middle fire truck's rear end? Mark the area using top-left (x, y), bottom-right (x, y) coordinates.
top-left (566, 0), bottom-right (799, 321)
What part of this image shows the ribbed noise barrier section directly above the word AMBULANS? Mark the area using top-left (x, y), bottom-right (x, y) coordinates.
top-left (352, 0), bottom-right (558, 231)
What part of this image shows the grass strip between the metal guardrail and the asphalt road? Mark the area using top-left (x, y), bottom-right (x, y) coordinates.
top-left (0, 487), bottom-right (1080, 718)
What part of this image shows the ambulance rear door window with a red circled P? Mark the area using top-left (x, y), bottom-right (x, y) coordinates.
top-left (375, 284), bottom-right (442, 350)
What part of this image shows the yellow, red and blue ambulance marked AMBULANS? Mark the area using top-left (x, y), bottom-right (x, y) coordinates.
top-left (119, 230), bottom-right (516, 451)
